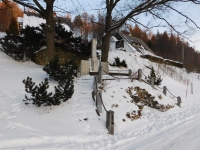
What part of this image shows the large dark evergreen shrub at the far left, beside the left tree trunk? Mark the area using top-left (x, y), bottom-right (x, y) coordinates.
top-left (0, 26), bottom-right (45, 61)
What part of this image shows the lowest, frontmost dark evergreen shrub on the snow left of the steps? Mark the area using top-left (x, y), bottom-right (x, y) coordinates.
top-left (23, 77), bottom-right (74, 107)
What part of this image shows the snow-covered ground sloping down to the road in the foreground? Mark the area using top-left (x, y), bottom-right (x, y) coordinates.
top-left (0, 31), bottom-right (200, 150)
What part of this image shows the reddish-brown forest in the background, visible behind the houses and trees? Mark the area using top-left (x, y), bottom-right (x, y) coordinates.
top-left (0, 2), bottom-right (200, 72)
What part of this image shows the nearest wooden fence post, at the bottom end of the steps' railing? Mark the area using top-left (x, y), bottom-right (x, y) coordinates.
top-left (106, 110), bottom-right (114, 135)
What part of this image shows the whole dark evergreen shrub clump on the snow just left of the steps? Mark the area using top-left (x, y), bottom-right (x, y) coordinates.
top-left (23, 56), bottom-right (77, 107)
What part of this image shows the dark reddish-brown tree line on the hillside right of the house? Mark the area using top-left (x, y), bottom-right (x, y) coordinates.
top-left (129, 26), bottom-right (200, 72)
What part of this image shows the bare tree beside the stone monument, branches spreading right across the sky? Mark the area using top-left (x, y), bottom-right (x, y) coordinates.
top-left (102, 0), bottom-right (200, 62)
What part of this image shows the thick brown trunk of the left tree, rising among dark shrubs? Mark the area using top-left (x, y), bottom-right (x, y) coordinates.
top-left (45, 0), bottom-right (55, 63)
